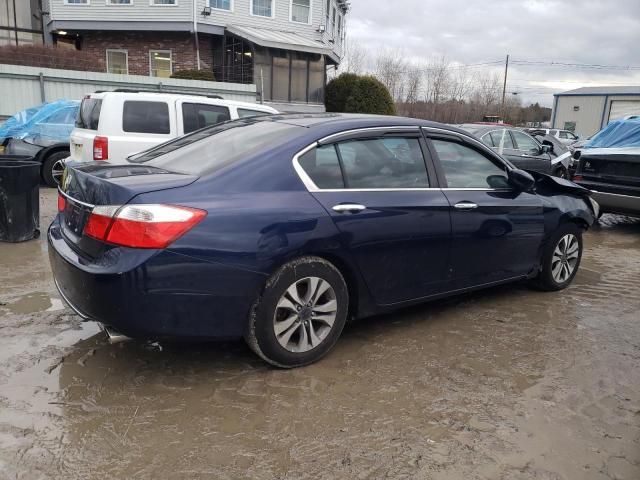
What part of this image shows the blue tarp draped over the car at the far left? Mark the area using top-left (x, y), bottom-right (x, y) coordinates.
top-left (0, 100), bottom-right (80, 143)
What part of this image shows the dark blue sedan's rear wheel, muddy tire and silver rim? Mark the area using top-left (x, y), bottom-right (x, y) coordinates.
top-left (245, 257), bottom-right (349, 368)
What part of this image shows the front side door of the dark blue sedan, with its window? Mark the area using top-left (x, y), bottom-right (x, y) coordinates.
top-left (431, 138), bottom-right (544, 289)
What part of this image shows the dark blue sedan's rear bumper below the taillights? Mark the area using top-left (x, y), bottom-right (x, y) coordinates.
top-left (48, 221), bottom-right (266, 339)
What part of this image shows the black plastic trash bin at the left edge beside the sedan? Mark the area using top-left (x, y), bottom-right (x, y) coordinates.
top-left (0, 155), bottom-right (40, 242)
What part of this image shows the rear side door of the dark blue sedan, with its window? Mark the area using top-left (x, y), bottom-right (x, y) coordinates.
top-left (299, 132), bottom-right (451, 305)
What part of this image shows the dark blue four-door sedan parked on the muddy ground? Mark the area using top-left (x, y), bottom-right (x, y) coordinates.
top-left (48, 114), bottom-right (598, 367)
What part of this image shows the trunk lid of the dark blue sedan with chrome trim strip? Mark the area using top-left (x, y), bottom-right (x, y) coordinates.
top-left (59, 163), bottom-right (198, 257)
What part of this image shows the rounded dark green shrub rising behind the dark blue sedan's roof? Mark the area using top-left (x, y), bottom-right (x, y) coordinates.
top-left (325, 73), bottom-right (395, 115)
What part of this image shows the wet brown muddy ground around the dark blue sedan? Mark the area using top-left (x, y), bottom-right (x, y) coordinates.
top-left (0, 190), bottom-right (640, 480)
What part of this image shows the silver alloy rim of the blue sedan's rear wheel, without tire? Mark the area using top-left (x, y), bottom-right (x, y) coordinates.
top-left (273, 277), bottom-right (338, 353)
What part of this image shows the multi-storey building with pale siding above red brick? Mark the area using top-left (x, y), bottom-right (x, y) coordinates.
top-left (37, 0), bottom-right (349, 110)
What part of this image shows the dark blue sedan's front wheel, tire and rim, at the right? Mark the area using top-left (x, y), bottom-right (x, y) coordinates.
top-left (534, 223), bottom-right (582, 292)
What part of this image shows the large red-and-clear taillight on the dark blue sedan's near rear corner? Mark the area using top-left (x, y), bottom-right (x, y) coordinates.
top-left (84, 205), bottom-right (207, 248)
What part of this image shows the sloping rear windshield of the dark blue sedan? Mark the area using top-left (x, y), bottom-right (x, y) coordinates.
top-left (128, 119), bottom-right (303, 175)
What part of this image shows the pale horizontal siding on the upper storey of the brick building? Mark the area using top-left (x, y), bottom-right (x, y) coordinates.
top-left (49, 0), bottom-right (345, 56)
